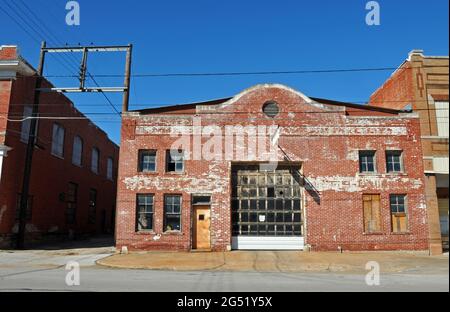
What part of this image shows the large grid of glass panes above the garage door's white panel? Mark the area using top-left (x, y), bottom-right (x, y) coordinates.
top-left (232, 167), bottom-right (303, 236)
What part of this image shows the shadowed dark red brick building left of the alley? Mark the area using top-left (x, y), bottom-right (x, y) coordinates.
top-left (0, 46), bottom-right (119, 247)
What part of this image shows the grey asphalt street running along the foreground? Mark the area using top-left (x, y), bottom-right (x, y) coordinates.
top-left (0, 251), bottom-right (449, 292)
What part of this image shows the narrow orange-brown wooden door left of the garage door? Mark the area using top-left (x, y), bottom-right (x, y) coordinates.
top-left (193, 206), bottom-right (211, 250)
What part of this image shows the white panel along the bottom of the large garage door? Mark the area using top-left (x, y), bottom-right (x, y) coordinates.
top-left (232, 236), bottom-right (305, 250)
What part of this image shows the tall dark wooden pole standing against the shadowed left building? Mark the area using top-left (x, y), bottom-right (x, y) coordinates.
top-left (16, 42), bottom-right (46, 250)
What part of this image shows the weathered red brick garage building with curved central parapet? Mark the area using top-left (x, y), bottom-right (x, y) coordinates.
top-left (116, 85), bottom-right (429, 250)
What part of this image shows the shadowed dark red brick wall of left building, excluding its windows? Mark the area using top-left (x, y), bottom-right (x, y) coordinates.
top-left (0, 46), bottom-right (119, 246)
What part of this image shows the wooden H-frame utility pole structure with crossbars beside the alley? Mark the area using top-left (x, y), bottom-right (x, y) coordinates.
top-left (16, 42), bottom-right (133, 249)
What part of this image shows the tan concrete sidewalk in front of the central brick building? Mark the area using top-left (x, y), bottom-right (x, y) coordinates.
top-left (97, 251), bottom-right (449, 274)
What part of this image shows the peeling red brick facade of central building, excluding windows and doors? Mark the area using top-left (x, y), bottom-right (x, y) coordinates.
top-left (116, 85), bottom-right (428, 250)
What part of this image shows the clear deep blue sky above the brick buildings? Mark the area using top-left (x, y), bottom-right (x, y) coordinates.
top-left (0, 0), bottom-right (449, 142)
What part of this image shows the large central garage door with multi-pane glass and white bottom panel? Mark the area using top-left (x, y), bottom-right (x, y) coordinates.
top-left (231, 164), bottom-right (304, 250)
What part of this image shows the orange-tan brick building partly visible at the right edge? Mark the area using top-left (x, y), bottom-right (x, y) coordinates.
top-left (370, 50), bottom-right (449, 253)
